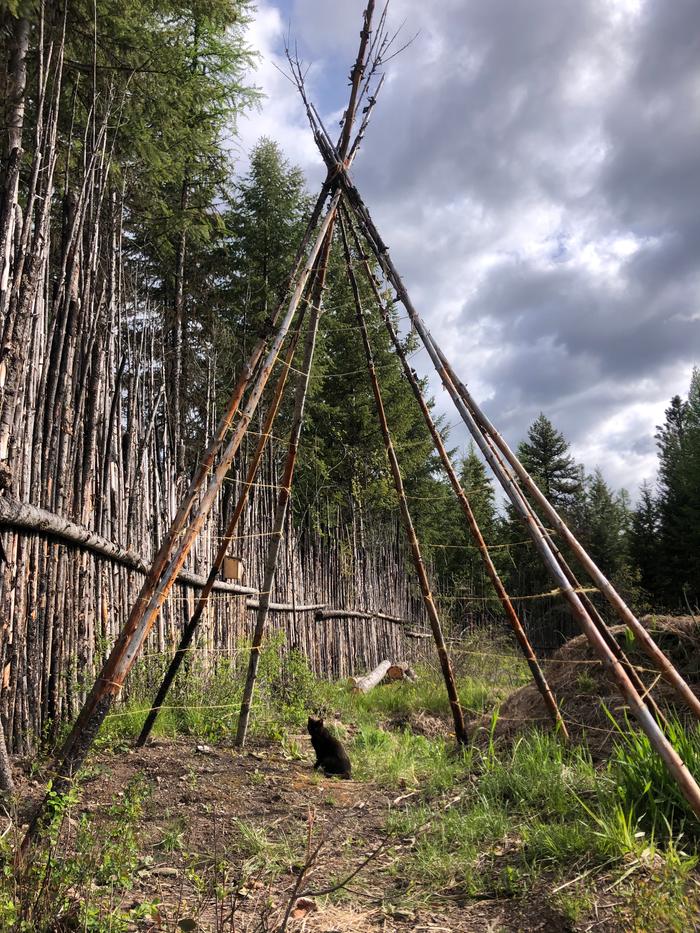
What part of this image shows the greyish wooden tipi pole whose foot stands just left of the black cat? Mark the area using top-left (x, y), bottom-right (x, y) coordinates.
top-left (236, 224), bottom-right (333, 747)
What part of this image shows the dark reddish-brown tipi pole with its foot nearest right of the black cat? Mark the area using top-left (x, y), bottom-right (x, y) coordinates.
top-left (340, 209), bottom-right (467, 745)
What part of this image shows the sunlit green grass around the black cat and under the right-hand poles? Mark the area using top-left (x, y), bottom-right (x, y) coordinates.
top-left (64, 639), bottom-right (700, 931)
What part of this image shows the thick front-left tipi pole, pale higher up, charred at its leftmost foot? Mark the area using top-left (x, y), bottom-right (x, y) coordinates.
top-left (19, 190), bottom-right (340, 861)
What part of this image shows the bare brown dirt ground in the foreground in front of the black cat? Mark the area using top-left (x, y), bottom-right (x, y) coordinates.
top-left (15, 736), bottom-right (619, 933)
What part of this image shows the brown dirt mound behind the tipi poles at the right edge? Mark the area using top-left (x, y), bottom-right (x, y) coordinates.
top-left (472, 616), bottom-right (700, 757)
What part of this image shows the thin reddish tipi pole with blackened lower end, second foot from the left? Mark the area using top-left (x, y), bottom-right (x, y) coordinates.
top-left (136, 317), bottom-right (303, 748)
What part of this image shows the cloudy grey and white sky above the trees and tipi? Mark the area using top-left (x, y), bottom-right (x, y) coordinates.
top-left (232, 0), bottom-right (700, 495)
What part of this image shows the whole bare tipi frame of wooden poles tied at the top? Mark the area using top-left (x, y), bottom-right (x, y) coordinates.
top-left (21, 0), bottom-right (700, 855)
